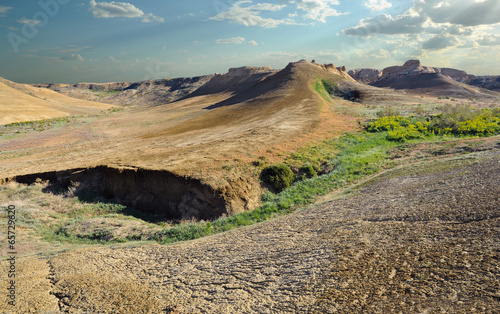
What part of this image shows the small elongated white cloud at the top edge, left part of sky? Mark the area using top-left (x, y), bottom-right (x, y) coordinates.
top-left (90, 0), bottom-right (164, 23)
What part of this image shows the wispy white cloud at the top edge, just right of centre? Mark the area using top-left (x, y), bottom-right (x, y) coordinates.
top-left (209, 0), bottom-right (293, 28)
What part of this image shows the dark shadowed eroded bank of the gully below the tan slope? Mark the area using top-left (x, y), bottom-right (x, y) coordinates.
top-left (0, 166), bottom-right (260, 220)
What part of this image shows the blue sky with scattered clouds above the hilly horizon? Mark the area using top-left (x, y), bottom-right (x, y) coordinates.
top-left (0, 0), bottom-right (500, 83)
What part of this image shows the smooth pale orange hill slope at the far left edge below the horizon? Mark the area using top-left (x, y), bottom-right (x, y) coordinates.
top-left (0, 78), bottom-right (111, 124)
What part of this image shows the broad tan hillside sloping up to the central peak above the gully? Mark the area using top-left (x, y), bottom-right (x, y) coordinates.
top-left (0, 61), bottom-right (357, 219)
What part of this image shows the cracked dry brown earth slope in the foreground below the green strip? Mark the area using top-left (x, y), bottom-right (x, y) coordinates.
top-left (2, 149), bottom-right (500, 313)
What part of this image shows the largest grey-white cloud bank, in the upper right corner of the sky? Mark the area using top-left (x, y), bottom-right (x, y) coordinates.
top-left (343, 0), bottom-right (500, 50)
